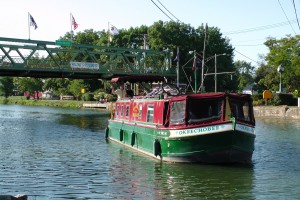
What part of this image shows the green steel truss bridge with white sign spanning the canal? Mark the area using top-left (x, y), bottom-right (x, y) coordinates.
top-left (0, 37), bottom-right (176, 79)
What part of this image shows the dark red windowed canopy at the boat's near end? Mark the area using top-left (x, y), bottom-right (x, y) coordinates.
top-left (166, 93), bottom-right (255, 126)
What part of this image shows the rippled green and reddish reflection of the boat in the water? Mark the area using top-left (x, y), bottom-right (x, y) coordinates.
top-left (104, 143), bottom-right (254, 199)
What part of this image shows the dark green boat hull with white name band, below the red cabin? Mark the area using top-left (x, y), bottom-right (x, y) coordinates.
top-left (106, 120), bottom-right (255, 163)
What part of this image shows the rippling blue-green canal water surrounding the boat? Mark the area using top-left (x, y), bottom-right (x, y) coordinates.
top-left (0, 105), bottom-right (300, 200)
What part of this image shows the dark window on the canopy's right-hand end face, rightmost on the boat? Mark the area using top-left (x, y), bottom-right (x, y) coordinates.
top-left (230, 99), bottom-right (252, 122)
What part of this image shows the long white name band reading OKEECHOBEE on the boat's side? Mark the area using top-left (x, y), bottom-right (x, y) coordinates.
top-left (170, 123), bottom-right (233, 137)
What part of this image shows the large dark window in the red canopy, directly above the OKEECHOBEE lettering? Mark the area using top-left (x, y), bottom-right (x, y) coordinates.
top-left (188, 98), bottom-right (222, 123)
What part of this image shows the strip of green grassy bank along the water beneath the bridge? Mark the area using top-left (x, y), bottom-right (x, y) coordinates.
top-left (0, 96), bottom-right (84, 108)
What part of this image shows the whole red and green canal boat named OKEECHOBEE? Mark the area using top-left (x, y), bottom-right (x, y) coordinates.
top-left (106, 77), bottom-right (255, 164)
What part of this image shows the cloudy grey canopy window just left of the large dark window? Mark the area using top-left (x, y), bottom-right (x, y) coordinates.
top-left (170, 101), bottom-right (186, 124)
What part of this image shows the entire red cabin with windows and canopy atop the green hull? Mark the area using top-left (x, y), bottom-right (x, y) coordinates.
top-left (114, 93), bottom-right (255, 128)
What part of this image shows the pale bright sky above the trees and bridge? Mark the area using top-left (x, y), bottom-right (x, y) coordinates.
top-left (0, 0), bottom-right (300, 67)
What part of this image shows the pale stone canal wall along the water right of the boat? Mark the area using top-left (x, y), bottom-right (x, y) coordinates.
top-left (254, 105), bottom-right (300, 119)
